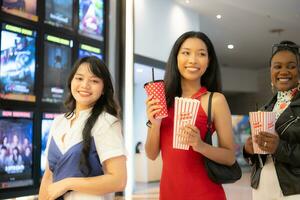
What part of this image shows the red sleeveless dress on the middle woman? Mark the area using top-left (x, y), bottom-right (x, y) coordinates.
top-left (160, 87), bottom-right (226, 200)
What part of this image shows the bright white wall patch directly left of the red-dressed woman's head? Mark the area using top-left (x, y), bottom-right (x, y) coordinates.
top-left (134, 0), bottom-right (200, 62)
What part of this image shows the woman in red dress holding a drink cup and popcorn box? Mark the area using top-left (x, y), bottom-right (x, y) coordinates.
top-left (146, 31), bottom-right (235, 200)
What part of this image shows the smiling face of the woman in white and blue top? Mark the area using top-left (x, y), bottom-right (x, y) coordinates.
top-left (71, 63), bottom-right (104, 111)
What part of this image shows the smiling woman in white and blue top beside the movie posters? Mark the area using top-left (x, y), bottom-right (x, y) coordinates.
top-left (39, 57), bottom-right (127, 200)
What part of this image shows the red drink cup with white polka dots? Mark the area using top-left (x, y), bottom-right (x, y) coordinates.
top-left (144, 80), bottom-right (168, 119)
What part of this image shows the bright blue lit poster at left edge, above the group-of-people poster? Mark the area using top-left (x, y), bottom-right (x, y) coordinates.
top-left (0, 24), bottom-right (36, 102)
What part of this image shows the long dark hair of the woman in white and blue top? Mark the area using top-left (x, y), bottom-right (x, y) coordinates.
top-left (65, 56), bottom-right (119, 175)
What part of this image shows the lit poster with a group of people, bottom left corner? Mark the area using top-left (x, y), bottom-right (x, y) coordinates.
top-left (0, 110), bottom-right (33, 189)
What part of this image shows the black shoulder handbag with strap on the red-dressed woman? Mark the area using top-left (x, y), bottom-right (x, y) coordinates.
top-left (204, 92), bottom-right (242, 184)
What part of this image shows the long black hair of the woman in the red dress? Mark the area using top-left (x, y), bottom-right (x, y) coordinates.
top-left (164, 31), bottom-right (221, 107)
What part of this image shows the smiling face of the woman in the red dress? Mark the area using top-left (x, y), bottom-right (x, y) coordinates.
top-left (177, 38), bottom-right (209, 84)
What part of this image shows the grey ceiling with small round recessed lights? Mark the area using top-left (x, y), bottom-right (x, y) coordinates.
top-left (174, 0), bottom-right (300, 69)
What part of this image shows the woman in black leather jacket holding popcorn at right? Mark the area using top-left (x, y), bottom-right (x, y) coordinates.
top-left (244, 41), bottom-right (300, 200)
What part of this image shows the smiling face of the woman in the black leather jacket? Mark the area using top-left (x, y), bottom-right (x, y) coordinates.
top-left (271, 51), bottom-right (299, 91)
